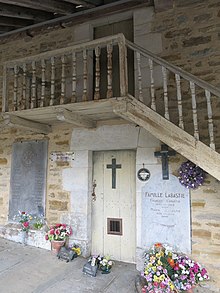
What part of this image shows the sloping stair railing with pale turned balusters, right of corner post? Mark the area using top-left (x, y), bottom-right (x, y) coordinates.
top-left (126, 40), bottom-right (220, 150)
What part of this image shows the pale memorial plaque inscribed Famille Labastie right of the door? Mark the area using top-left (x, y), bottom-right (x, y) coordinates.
top-left (142, 174), bottom-right (191, 253)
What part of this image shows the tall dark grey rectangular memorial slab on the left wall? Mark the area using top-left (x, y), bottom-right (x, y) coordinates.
top-left (9, 140), bottom-right (48, 219)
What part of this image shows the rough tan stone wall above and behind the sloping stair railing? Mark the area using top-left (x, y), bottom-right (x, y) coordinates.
top-left (151, 0), bottom-right (220, 151)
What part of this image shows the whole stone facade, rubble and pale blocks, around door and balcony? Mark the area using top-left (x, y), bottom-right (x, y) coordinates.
top-left (0, 0), bottom-right (220, 292)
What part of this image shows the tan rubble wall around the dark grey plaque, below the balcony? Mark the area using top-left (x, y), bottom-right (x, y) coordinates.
top-left (0, 124), bottom-right (72, 225)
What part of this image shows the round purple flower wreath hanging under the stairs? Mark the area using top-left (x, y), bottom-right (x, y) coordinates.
top-left (178, 161), bottom-right (205, 189)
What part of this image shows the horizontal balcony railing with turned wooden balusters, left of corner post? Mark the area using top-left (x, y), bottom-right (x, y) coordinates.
top-left (2, 35), bottom-right (128, 112)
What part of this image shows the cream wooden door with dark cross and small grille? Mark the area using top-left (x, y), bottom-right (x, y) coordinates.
top-left (92, 151), bottom-right (136, 263)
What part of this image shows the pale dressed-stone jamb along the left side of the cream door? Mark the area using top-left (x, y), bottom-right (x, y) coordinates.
top-left (63, 150), bottom-right (92, 257)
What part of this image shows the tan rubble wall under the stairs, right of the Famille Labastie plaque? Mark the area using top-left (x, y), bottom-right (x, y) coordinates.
top-left (169, 155), bottom-right (220, 292)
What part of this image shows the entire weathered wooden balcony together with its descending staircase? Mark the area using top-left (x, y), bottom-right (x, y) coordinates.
top-left (2, 34), bottom-right (220, 180)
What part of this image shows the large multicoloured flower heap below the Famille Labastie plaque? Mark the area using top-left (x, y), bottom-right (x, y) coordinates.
top-left (142, 243), bottom-right (209, 293)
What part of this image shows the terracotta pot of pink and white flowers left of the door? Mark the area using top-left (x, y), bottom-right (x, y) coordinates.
top-left (45, 223), bottom-right (72, 254)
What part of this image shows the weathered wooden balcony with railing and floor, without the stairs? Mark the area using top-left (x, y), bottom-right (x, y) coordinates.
top-left (2, 35), bottom-right (128, 133)
